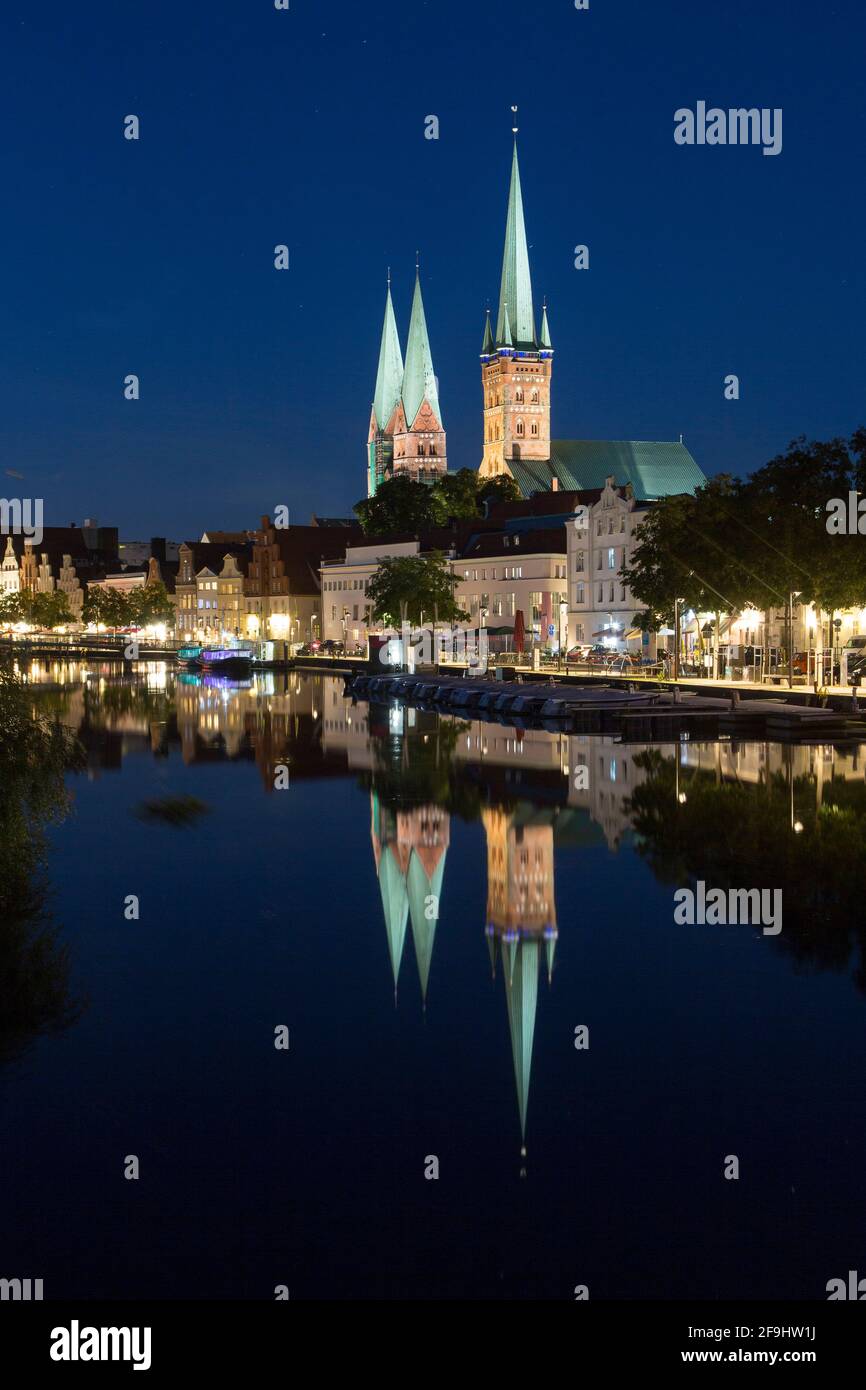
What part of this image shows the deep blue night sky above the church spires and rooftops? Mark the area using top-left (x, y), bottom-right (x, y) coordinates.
top-left (0, 0), bottom-right (866, 538)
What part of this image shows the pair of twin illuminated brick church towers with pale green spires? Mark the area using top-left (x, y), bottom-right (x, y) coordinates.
top-left (367, 267), bottom-right (448, 496)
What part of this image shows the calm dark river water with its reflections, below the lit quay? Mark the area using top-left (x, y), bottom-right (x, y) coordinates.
top-left (0, 666), bottom-right (866, 1300)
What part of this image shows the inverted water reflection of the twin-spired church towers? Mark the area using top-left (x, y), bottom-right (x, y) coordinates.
top-left (370, 792), bottom-right (450, 1001)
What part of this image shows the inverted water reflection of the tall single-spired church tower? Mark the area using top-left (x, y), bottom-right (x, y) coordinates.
top-left (481, 809), bottom-right (557, 1143)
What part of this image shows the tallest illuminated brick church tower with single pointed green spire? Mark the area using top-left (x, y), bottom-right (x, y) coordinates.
top-left (478, 115), bottom-right (553, 478)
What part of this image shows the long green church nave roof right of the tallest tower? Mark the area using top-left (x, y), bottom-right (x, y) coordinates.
top-left (506, 439), bottom-right (706, 502)
